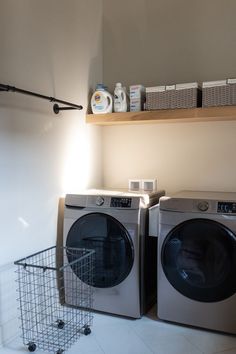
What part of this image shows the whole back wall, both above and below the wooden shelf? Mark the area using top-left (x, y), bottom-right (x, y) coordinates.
top-left (103, 0), bottom-right (236, 193)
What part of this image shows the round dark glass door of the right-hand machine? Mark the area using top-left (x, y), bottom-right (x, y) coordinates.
top-left (161, 219), bottom-right (236, 302)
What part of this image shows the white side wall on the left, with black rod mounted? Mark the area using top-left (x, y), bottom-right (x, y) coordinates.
top-left (0, 0), bottom-right (102, 344)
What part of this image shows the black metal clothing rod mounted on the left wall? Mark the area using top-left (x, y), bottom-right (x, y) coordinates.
top-left (0, 84), bottom-right (83, 113)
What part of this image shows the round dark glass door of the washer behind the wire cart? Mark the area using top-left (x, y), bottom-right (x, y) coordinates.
top-left (66, 213), bottom-right (134, 288)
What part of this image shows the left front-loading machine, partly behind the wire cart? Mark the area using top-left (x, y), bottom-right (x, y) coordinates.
top-left (63, 190), bottom-right (164, 318)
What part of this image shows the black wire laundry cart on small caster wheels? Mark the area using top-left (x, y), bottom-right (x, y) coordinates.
top-left (14, 246), bottom-right (94, 354)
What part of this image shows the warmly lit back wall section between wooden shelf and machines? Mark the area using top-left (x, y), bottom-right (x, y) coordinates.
top-left (103, 122), bottom-right (236, 193)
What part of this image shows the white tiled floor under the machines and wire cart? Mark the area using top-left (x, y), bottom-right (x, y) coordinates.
top-left (0, 308), bottom-right (236, 354)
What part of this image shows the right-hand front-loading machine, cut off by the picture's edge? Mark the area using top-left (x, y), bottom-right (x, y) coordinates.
top-left (157, 191), bottom-right (236, 334)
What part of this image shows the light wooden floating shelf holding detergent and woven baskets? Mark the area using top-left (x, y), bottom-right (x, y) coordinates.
top-left (86, 106), bottom-right (236, 125)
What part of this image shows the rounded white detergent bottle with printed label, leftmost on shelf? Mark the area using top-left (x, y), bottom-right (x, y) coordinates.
top-left (91, 84), bottom-right (113, 114)
